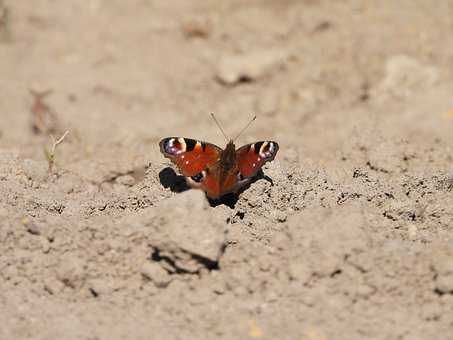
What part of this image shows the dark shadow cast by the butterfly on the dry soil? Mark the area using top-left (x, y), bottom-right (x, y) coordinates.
top-left (159, 167), bottom-right (274, 209)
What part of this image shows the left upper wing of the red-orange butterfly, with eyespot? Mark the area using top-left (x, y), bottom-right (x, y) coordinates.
top-left (159, 137), bottom-right (222, 177)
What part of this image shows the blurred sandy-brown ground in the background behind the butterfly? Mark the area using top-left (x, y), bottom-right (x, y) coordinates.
top-left (0, 0), bottom-right (453, 167)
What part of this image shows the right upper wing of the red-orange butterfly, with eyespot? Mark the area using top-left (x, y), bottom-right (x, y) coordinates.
top-left (236, 141), bottom-right (279, 178)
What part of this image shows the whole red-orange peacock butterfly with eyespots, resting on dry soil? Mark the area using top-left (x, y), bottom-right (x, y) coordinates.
top-left (159, 115), bottom-right (279, 199)
